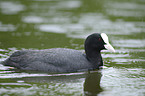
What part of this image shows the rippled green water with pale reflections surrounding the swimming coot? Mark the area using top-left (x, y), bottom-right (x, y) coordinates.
top-left (0, 0), bottom-right (145, 96)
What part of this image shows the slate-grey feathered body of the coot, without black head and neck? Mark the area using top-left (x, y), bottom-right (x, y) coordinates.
top-left (2, 48), bottom-right (102, 72)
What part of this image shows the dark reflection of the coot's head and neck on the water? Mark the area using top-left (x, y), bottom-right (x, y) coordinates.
top-left (84, 71), bottom-right (103, 96)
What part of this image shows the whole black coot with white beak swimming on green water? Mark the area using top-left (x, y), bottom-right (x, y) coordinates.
top-left (3, 33), bottom-right (115, 73)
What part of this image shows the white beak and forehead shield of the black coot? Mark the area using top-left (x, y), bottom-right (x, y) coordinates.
top-left (101, 33), bottom-right (115, 52)
